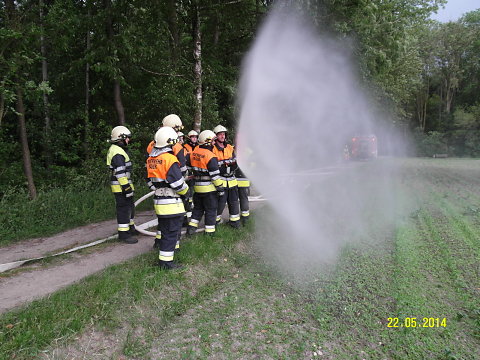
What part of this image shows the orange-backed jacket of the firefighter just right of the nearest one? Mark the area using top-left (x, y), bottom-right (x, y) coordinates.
top-left (187, 145), bottom-right (223, 193)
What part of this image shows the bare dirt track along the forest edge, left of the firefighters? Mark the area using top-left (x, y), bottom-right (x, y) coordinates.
top-left (0, 203), bottom-right (266, 314)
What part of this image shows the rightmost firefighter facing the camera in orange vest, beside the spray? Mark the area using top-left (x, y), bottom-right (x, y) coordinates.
top-left (213, 125), bottom-right (240, 228)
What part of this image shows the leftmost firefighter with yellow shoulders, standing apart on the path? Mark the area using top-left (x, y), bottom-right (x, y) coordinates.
top-left (107, 126), bottom-right (138, 244)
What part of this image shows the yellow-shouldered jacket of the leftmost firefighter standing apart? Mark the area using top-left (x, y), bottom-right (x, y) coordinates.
top-left (107, 144), bottom-right (133, 193)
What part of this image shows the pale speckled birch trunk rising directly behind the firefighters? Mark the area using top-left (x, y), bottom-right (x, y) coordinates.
top-left (193, 2), bottom-right (203, 132)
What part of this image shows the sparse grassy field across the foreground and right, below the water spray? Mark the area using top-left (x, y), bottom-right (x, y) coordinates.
top-left (0, 159), bottom-right (480, 360)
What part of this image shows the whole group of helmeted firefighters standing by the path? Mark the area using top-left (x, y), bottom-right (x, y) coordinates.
top-left (107, 114), bottom-right (250, 269)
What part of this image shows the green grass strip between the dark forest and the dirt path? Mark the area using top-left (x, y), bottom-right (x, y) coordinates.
top-left (0, 187), bottom-right (151, 246)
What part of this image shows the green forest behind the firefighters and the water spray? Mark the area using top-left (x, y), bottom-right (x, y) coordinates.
top-left (0, 0), bottom-right (480, 202)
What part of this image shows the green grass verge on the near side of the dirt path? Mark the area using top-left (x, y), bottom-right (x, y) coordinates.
top-left (0, 221), bottom-right (255, 359)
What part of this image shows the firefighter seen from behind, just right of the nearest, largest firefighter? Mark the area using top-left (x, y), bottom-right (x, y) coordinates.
top-left (187, 130), bottom-right (225, 235)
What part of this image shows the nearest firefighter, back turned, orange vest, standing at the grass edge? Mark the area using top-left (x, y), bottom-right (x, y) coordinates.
top-left (147, 127), bottom-right (188, 270)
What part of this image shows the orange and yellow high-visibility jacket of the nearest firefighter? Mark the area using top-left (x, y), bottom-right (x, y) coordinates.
top-left (147, 147), bottom-right (188, 217)
